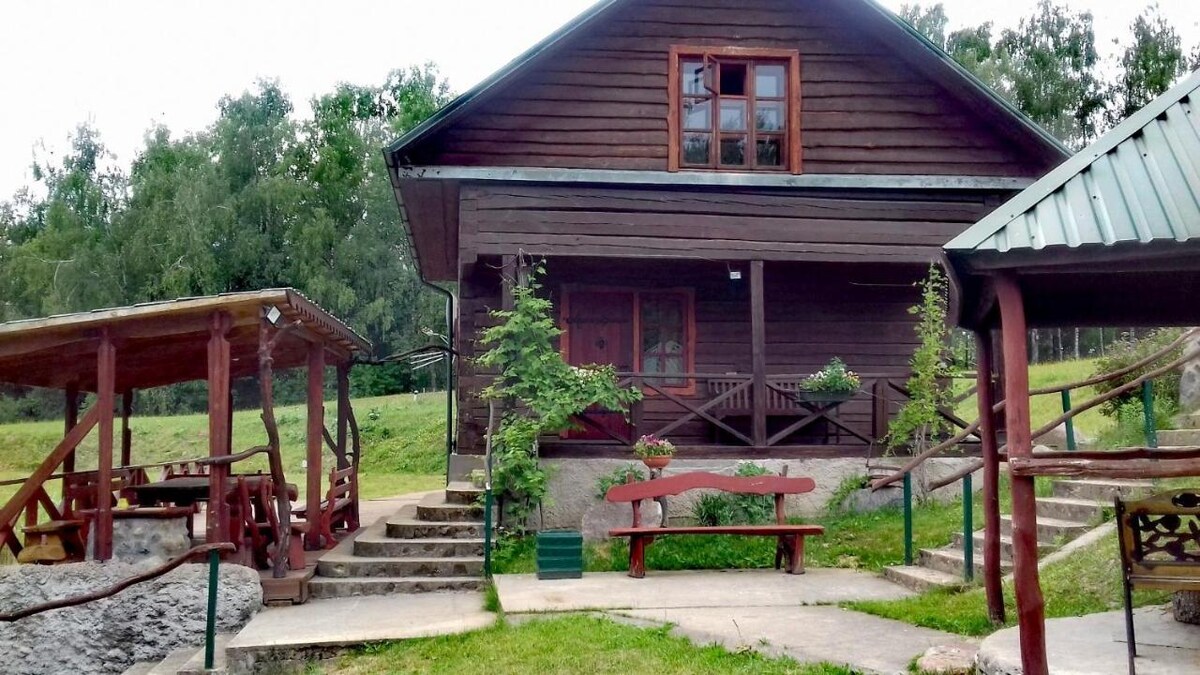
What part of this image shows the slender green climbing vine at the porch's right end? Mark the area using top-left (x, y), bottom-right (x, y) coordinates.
top-left (887, 264), bottom-right (953, 452)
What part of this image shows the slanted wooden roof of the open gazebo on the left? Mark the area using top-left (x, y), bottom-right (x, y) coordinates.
top-left (0, 288), bottom-right (371, 392)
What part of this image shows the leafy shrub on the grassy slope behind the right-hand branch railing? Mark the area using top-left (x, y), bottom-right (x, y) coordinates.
top-left (1096, 328), bottom-right (1183, 415)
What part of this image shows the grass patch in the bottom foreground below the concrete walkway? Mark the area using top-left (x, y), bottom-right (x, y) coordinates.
top-left (323, 615), bottom-right (851, 675)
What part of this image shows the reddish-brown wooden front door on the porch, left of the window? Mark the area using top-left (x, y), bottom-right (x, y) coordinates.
top-left (566, 291), bottom-right (634, 441)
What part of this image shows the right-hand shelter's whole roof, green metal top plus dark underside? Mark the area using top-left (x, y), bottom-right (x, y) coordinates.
top-left (946, 71), bottom-right (1200, 328)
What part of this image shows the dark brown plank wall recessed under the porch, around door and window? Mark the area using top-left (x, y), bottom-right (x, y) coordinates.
top-left (458, 258), bottom-right (925, 453)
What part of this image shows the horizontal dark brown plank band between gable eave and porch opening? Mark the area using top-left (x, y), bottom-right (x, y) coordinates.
top-left (460, 184), bottom-right (1003, 262)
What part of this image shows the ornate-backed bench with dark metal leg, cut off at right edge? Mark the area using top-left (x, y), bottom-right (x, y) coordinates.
top-left (1116, 490), bottom-right (1200, 675)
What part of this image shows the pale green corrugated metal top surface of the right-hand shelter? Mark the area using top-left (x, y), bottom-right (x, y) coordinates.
top-left (946, 71), bottom-right (1200, 253)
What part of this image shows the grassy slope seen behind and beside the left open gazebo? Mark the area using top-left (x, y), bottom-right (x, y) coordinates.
top-left (0, 393), bottom-right (445, 503)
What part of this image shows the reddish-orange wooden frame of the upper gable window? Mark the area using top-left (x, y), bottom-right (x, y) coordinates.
top-left (667, 46), bottom-right (802, 174)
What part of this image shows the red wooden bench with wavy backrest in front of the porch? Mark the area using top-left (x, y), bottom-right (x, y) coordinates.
top-left (605, 471), bottom-right (824, 571)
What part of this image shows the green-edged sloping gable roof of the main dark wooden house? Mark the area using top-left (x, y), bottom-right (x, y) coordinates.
top-left (384, 0), bottom-right (1070, 169)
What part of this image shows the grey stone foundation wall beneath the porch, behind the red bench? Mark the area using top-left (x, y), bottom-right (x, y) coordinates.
top-left (535, 451), bottom-right (982, 530)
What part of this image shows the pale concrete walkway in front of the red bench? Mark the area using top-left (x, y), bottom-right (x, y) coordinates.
top-left (496, 569), bottom-right (974, 675)
